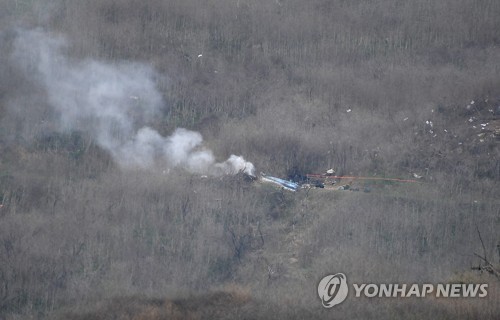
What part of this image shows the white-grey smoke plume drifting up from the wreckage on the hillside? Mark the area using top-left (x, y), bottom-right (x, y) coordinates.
top-left (13, 30), bottom-right (255, 176)
